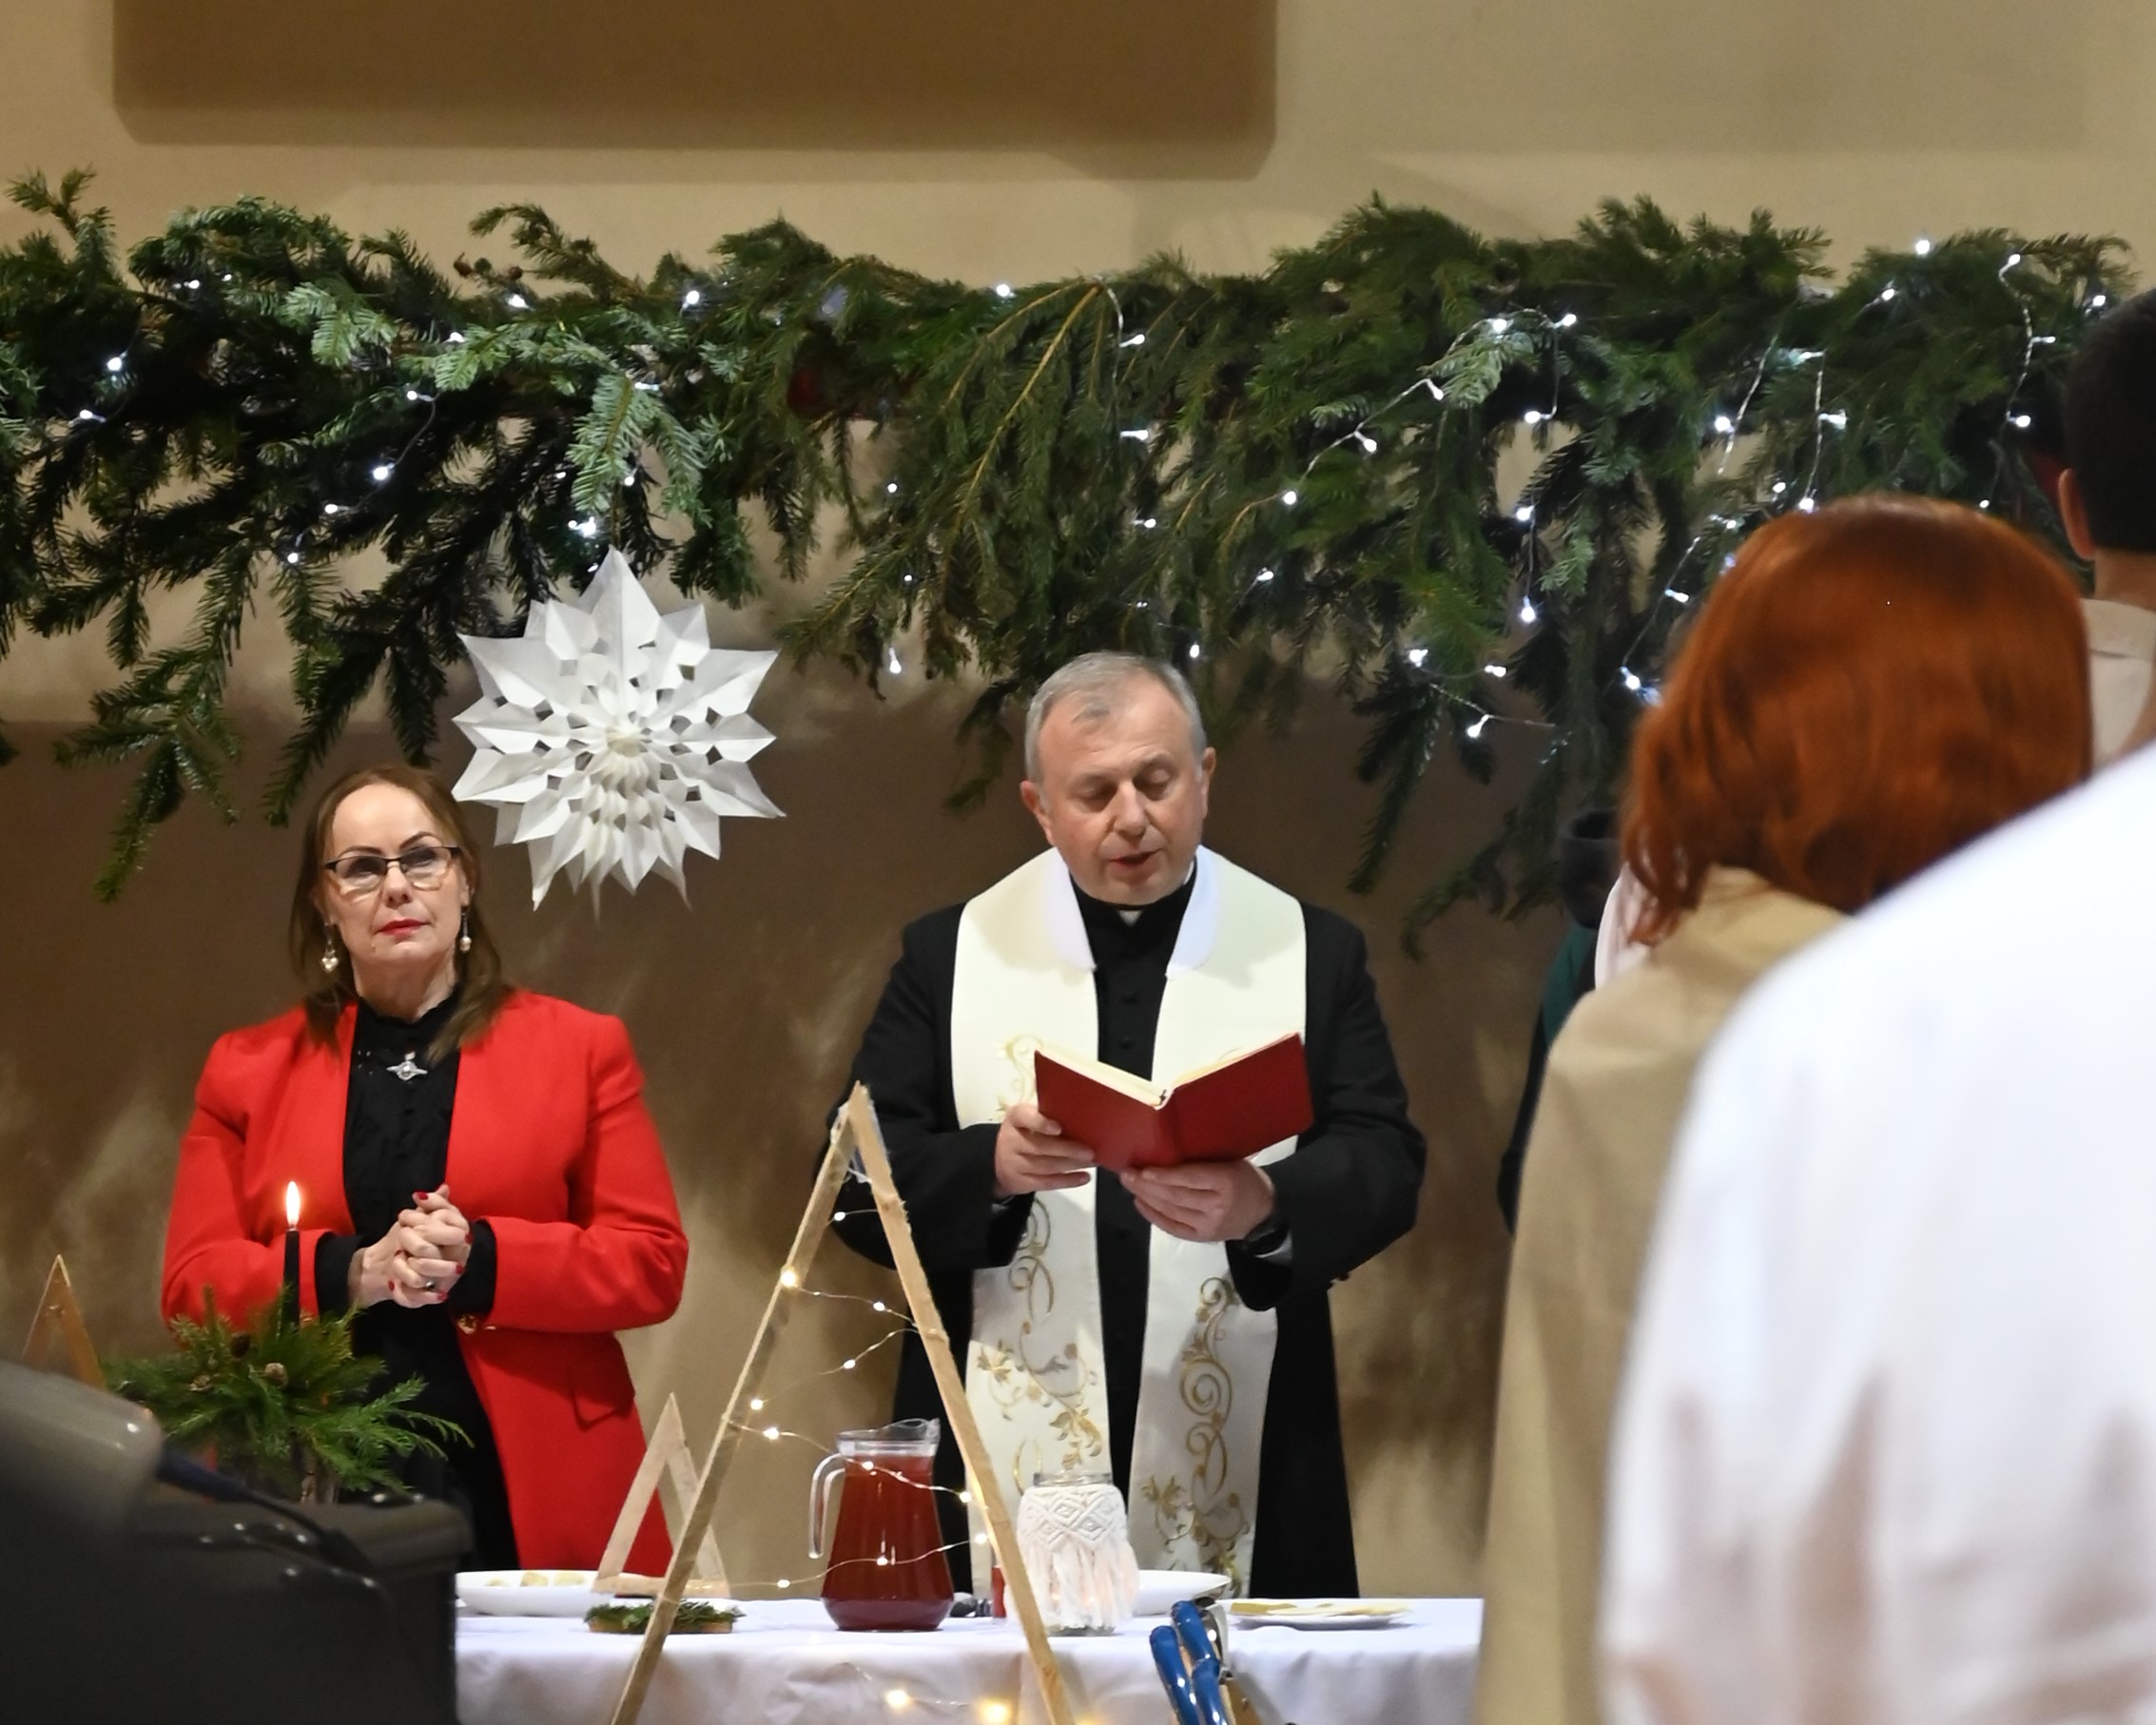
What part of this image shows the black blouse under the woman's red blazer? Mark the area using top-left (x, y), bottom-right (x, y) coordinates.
top-left (315, 994), bottom-right (517, 1570)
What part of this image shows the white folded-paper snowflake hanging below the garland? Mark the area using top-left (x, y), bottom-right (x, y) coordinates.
top-left (455, 552), bottom-right (781, 903)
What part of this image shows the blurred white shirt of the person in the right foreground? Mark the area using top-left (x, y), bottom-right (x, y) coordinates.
top-left (1602, 755), bottom-right (2156, 1725)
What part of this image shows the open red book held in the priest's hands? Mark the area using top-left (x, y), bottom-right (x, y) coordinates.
top-left (1033, 1031), bottom-right (1313, 1173)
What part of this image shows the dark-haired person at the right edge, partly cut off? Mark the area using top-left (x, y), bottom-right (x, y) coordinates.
top-left (2059, 293), bottom-right (2156, 764)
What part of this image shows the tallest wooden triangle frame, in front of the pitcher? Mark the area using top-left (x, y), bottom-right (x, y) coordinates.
top-left (612, 1085), bottom-right (1074, 1725)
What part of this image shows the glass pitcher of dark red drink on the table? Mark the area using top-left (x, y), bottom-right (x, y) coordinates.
top-left (808, 1419), bottom-right (951, 1630)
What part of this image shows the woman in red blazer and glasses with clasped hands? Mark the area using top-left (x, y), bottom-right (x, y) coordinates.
top-left (164, 767), bottom-right (688, 1574)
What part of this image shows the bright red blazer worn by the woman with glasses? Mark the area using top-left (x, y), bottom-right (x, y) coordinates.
top-left (164, 992), bottom-right (688, 1574)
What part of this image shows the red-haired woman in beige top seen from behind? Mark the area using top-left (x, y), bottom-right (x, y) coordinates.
top-left (1475, 496), bottom-right (2089, 1725)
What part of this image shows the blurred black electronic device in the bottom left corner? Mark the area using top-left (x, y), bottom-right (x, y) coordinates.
top-left (0, 1363), bottom-right (470, 1725)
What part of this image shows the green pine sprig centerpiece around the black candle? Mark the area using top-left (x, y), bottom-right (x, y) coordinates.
top-left (106, 1296), bottom-right (463, 1497)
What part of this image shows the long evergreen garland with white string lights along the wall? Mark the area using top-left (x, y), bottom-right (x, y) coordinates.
top-left (0, 172), bottom-right (2126, 940)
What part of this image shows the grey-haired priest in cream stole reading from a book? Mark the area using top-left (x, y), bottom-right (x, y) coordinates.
top-left (837, 653), bottom-right (1423, 1596)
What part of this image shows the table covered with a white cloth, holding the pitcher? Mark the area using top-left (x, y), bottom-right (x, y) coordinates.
top-left (457, 1599), bottom-right (1481, 1725)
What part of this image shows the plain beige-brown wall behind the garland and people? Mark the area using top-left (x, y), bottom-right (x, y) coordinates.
top-left (0, 0), bottom-right (2156, 1591)
